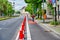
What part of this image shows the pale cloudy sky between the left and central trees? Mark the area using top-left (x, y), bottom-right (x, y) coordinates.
top-left (8, 0), bottom-right (27, 10)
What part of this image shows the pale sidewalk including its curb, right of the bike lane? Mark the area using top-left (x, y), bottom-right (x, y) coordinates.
top-left (36, 20), bottom-right (60, 36)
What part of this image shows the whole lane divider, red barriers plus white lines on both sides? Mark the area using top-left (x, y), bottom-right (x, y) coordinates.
top-left (16, 16), bottom-right (31, 40)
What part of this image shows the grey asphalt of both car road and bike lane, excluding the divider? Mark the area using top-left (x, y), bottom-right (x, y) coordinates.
top-left (0, 16), bottom-right (60, 40)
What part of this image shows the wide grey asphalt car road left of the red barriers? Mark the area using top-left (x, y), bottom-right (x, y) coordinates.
top-left (0, 16), bottom-right (24, 40)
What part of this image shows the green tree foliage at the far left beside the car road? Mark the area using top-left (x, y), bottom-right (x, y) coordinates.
top-left (0, 0), bottom-right (13, 16)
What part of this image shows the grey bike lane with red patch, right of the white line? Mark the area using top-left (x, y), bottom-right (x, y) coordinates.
top-left (28, 18), bottom-right (60, 40)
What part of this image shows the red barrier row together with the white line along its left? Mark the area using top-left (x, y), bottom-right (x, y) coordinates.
top-left (16, 16), bottom-right (26, 40)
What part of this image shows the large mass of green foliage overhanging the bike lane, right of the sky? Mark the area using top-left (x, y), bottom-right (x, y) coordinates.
top-left (25, 0), bottom-right (46, 18)
